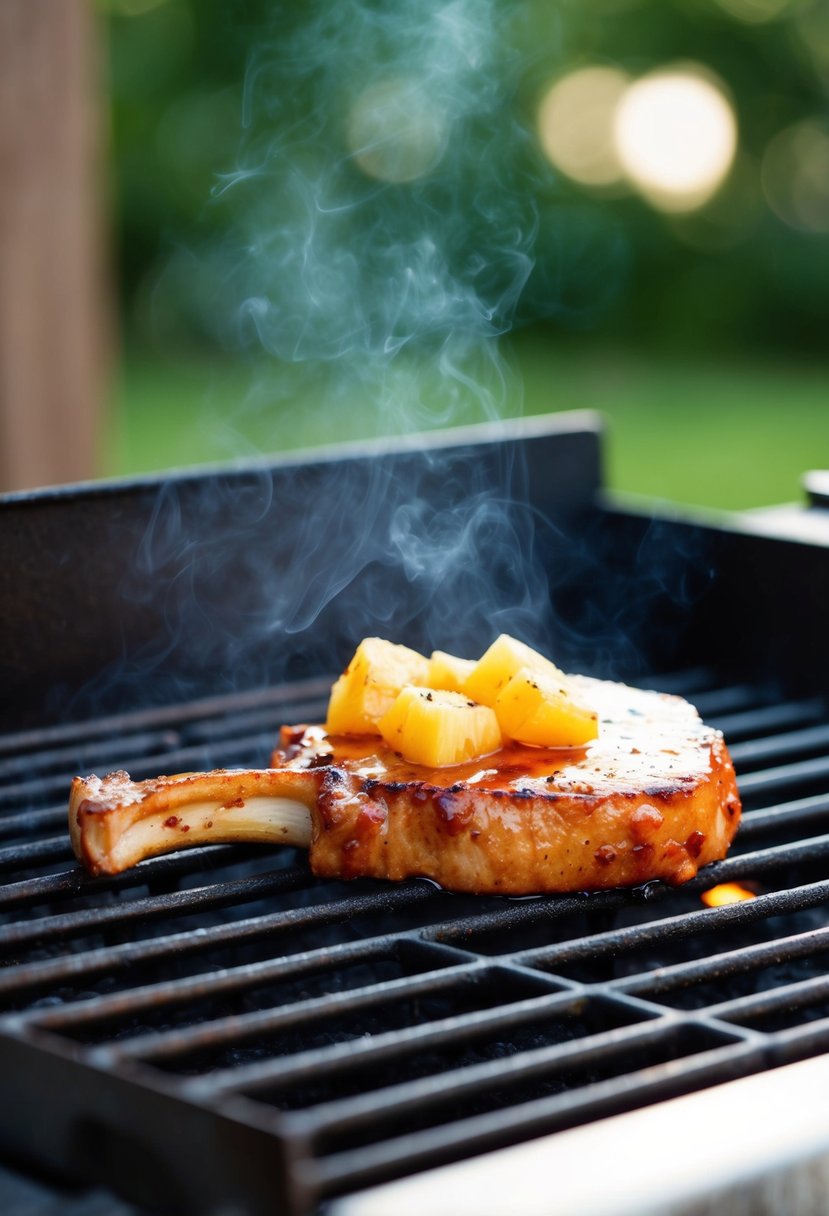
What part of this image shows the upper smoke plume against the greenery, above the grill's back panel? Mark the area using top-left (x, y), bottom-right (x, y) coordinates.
top-left (205, 0), bottom-right (538, 434)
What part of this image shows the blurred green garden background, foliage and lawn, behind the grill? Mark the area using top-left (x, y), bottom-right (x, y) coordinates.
top-left (98, 0), bottom-right (829, 507)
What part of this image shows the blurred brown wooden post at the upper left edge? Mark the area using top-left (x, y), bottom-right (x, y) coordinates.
top-left (0, 0), bottom-right (106, 491)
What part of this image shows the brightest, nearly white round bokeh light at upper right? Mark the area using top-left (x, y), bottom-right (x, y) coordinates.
top-left (607, 67), bottom-right (737, 212)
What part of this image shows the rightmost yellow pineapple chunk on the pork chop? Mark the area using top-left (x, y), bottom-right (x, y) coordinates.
top-left (495, 668), bottom-right (599, 748)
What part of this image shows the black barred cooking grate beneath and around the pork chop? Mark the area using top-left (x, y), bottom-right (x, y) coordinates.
top-left (0, 671), bottom-right (829, 1216)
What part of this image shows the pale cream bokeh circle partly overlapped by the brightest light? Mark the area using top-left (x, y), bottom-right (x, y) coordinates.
top-left (538, 67), bottom-right (630, 186)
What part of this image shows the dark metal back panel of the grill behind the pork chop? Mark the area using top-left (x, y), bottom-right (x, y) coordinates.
top-left (0, 415), bottom-right (600, 730)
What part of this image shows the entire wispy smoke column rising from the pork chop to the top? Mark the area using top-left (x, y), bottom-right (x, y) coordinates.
top-left (117, 0), bottom-right (632, 700)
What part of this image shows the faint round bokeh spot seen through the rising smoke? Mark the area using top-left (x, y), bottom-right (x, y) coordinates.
top-left (345, 77), bottom-right (447, 181)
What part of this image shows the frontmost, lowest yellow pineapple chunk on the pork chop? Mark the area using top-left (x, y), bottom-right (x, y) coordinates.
top-left (378, 686), bottom-right (501, 769)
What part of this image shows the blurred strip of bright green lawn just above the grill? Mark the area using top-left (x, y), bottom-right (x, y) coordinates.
top-left (101, 338), bottom-right (829, 510)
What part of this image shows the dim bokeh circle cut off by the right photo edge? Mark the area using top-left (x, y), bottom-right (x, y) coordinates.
top-left (762, 122), bottom-right (829, 232)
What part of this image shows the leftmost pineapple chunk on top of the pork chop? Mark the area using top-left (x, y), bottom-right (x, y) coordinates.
top-left (326, 637), bottom-right (429, 734)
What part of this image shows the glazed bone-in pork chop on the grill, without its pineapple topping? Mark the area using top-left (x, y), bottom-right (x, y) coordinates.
top-left (69, 676), bottom-right (740, 895)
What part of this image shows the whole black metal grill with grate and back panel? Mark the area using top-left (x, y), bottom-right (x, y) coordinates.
top-left (0, 413), bottom-right (829, 1216)
